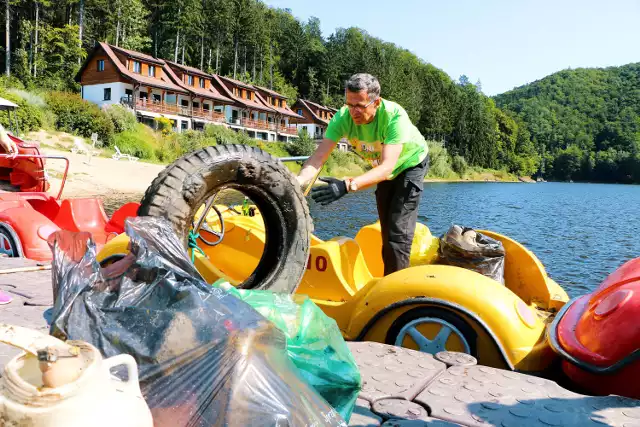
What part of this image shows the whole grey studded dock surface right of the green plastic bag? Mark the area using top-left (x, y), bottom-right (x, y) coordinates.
top-left (349, 343), bottom-right (640, 427)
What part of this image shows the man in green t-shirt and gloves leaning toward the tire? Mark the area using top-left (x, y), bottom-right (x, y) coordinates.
top-left (298, 74), bottom-right (429, 276)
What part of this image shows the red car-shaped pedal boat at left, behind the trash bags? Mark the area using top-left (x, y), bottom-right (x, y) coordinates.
top-left (0, 150), bottom-right (139, 261)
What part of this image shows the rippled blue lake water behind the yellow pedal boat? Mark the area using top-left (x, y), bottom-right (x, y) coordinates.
top-left (308, 183), bottom-right (640, 297)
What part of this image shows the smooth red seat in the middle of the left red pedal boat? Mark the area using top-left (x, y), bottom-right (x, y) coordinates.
top-left (54, 199), bottom-right (108, 234)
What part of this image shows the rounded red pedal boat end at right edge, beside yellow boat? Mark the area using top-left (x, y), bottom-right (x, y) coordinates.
top-left (548, 258), bottom-right (640, 399)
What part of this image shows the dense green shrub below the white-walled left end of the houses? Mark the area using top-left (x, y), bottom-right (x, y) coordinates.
top-left (46, 92), bottom-right (114, 143)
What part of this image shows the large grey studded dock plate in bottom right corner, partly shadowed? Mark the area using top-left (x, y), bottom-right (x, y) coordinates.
top-left (415, 366), bottom-right (640, 427)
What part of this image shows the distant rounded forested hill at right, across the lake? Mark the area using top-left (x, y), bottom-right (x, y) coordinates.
top-left (494, 63), bottom-right (640, 183)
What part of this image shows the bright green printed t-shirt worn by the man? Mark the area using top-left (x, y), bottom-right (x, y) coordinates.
top-left (325, 99), bottom-right (429, 179)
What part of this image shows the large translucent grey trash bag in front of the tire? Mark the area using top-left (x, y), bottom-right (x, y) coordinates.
top-left (49, 217), bottom-right (346, 427)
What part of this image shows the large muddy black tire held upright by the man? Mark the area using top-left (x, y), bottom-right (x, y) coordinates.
top-left (138, 145), bottom-right (313, 293)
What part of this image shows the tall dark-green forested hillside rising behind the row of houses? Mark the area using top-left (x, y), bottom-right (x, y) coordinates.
top-left (0, 0), bottom-right (539, 176)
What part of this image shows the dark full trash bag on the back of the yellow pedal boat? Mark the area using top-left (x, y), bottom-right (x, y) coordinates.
top-left (438, 225), bottom-right (504, 285)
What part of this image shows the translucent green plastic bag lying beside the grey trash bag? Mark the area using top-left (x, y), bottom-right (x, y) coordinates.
top-left (214, 281), bottom-right (362, 422)
